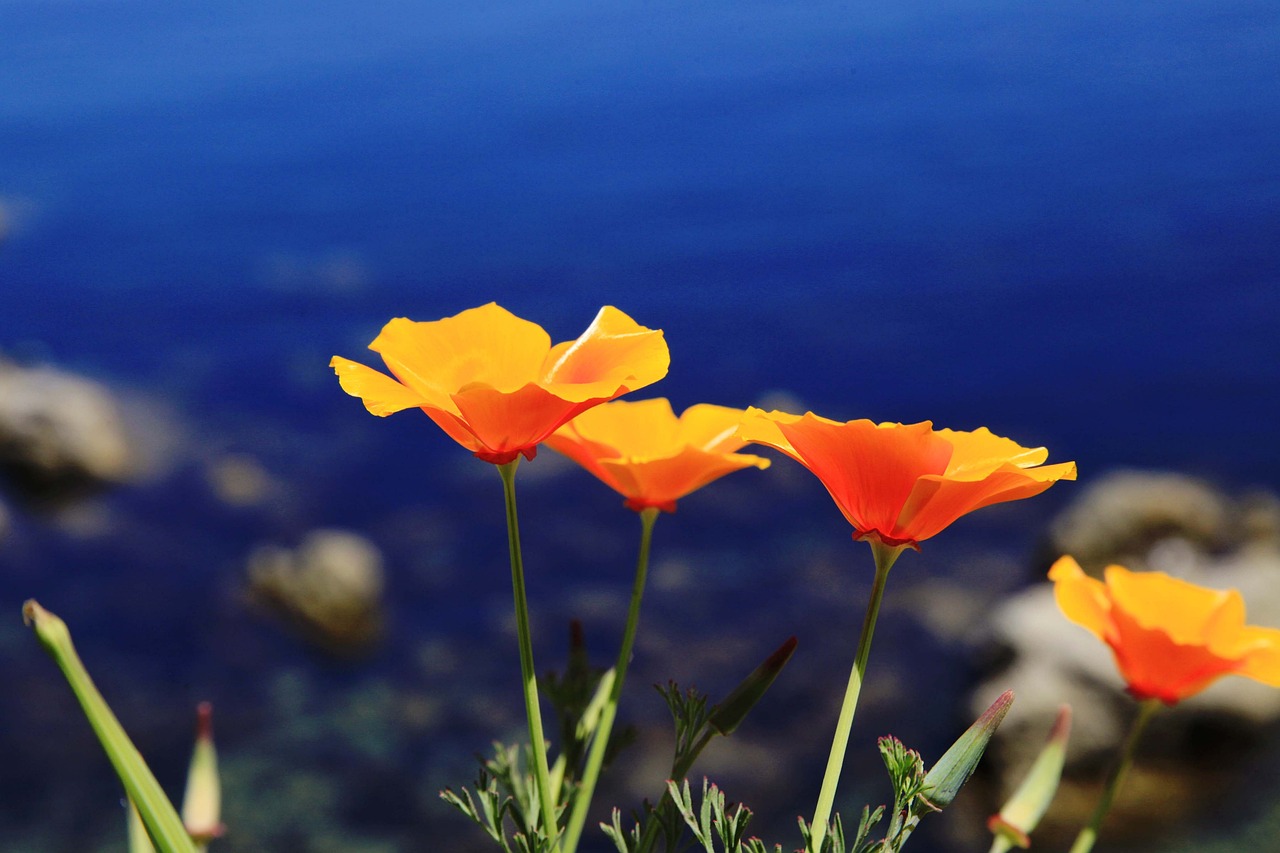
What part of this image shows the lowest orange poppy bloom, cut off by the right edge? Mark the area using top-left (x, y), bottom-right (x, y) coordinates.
top-left (1048, 557), bottom-right (1280, 704)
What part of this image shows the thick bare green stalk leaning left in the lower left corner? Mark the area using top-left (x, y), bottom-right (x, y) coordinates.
top-left (22, 599), bottom-right (196, 853)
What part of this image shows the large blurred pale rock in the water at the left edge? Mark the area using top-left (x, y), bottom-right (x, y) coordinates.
top-left (0, 361), bottom-right (137, 502)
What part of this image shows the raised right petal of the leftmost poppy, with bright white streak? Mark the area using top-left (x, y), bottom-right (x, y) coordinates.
top-left (541, 305), bottom-right (671, 401)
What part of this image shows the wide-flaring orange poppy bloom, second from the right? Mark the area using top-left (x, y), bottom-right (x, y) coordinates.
top-left (739, 409), bottom-right (1075, 549)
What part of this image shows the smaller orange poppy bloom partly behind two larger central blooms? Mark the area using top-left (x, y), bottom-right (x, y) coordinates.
top-left (547, 398), bottom-right (769, 512)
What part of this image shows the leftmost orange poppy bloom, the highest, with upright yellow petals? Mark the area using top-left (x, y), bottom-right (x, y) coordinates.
top-left (329, 302), bottom-right (671, 465)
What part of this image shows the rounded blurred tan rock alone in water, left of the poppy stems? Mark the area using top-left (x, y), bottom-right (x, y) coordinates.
top-left (248, 530), bottom-right (384, 654)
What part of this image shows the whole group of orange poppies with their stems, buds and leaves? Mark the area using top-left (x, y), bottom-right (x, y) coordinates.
top-left (23, 297), bottom-right (1280, 853)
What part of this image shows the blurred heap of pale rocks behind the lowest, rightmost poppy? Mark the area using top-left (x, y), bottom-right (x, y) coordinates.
top-left (969, 473), bottom-right (1280, 847)
